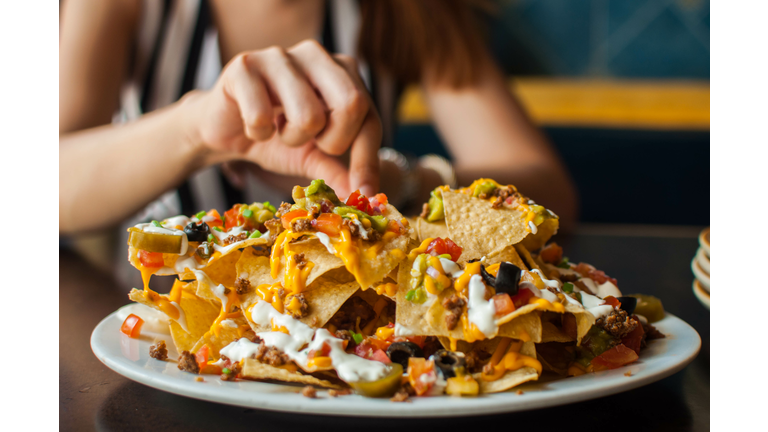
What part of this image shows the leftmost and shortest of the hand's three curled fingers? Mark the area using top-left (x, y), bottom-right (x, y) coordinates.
top-left (222, 54), bottom-right (275, 143)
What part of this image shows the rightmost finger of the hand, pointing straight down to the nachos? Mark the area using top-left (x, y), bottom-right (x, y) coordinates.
top-left (335, 56), bottom-right (382, 196)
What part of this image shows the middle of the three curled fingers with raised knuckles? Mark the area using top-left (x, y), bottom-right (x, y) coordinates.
top-left (249, 47), bottom-right (326, 147)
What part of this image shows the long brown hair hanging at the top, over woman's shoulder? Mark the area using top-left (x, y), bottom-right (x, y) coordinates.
top-left (359, 0), bottom-right (493, 88)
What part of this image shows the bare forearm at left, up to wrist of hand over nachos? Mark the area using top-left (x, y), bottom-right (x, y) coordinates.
top-left (59, 96), bottom-right (222, 233)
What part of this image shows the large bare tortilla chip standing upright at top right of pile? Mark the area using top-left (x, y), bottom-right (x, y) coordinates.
top-left (443, 191), bottom-right (528, 261)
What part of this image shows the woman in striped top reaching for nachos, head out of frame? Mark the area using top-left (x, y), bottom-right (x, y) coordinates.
top-left (59, 0), bottom-right (576, 233)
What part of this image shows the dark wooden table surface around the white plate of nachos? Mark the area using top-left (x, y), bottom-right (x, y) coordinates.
top-left (59, 226), bottom-right (710, 432)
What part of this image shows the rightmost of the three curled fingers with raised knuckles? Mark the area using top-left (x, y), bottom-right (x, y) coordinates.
top-left (288, 40), bottom-right (372, 155)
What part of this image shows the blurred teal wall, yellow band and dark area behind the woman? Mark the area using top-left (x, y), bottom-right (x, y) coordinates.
top-left (395, 0), bottom-right (710, 226)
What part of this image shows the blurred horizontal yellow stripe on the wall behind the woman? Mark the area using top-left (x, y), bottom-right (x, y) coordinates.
top-left (398, 78), bottom-right (709, 130)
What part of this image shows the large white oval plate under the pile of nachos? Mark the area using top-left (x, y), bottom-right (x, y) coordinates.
top-left (91, 312), bottom-right (701, 417)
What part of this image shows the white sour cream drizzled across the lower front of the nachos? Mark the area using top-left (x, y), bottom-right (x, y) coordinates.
top-left (237, 301), bottom-right (387, 382)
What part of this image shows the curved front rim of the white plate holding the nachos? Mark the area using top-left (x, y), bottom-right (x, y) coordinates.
top-left (90, 311), bottom-right (701, 418)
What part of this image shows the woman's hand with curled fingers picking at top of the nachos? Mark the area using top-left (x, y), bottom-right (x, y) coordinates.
top-left (182, 40), bottom-right (381, 196)
